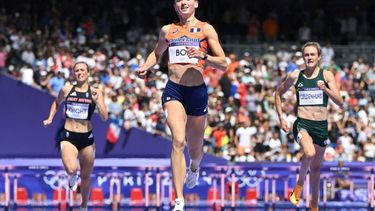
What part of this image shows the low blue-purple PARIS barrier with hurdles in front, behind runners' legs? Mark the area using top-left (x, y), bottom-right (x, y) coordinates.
top-left (0, 159), bottom-right (375, 211)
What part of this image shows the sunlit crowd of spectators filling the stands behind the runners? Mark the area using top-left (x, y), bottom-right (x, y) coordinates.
top-left (0, 2), bottom-right (375, 162)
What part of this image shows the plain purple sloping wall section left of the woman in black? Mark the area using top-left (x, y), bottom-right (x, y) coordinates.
top-left (0, 74), bottom-right (61, 158)
